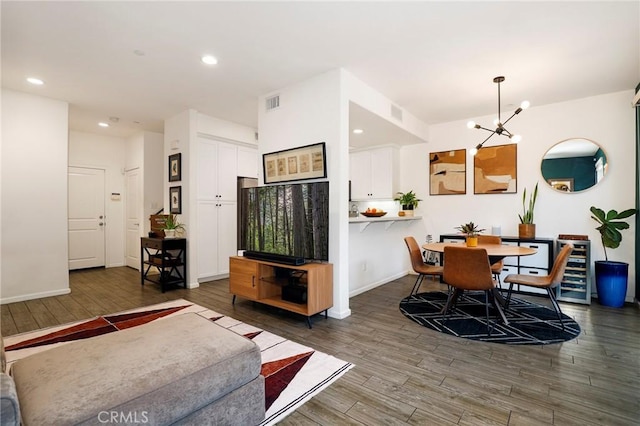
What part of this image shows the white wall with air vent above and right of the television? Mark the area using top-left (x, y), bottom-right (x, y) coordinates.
top-left (258, 70), bottom-right (350, 318)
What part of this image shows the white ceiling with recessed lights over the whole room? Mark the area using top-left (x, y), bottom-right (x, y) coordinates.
top-left (1, 1), bottom-right (640, 143)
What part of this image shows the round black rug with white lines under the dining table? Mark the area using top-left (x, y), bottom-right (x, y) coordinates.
top-left (400, 291), bottom-right (580, 345)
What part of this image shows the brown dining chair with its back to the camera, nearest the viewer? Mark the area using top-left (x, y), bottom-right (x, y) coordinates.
top-left (443, 245), bottom-right (504, 336)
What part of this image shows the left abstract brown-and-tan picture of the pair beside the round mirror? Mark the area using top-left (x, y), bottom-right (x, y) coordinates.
top-left (429, 149), bottom-right (467, 195)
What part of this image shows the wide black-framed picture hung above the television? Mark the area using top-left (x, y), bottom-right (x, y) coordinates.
top-left (262, 142), bottom-right (327, 183)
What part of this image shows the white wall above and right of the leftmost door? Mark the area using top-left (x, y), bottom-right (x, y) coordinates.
top-left (69, 130), bottom-right (127, 267)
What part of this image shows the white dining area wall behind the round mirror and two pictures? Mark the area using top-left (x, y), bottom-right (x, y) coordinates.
top-left (400, 90), bottom-right (635, 301)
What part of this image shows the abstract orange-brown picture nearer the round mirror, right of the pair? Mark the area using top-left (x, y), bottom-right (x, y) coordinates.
top-left (473, 143), bottom-right (518, 194)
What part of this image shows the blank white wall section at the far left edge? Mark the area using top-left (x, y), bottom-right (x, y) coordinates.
top-left (0, 89), bottom-right (69, 303)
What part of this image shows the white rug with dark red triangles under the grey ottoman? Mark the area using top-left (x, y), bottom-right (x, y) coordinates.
top-left (4, 299), bottom-right (353, 425)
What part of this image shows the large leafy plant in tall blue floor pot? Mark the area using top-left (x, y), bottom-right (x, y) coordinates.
top-left (590, 206), bottom-right (637, 308)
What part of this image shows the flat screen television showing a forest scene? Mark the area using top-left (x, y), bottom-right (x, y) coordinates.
top-left (239, 181), bottom-right (329, 264)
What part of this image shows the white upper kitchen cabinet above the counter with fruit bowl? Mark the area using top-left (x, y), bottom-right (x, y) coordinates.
top-left (349, 147), bottom-right (398, 201)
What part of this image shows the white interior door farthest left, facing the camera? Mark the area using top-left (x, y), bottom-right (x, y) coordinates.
top-left (69, 167), bottom-right (106, 270)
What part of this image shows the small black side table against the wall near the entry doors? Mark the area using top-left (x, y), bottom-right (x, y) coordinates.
top-left (140, 237), bottom-right (187, 293)
